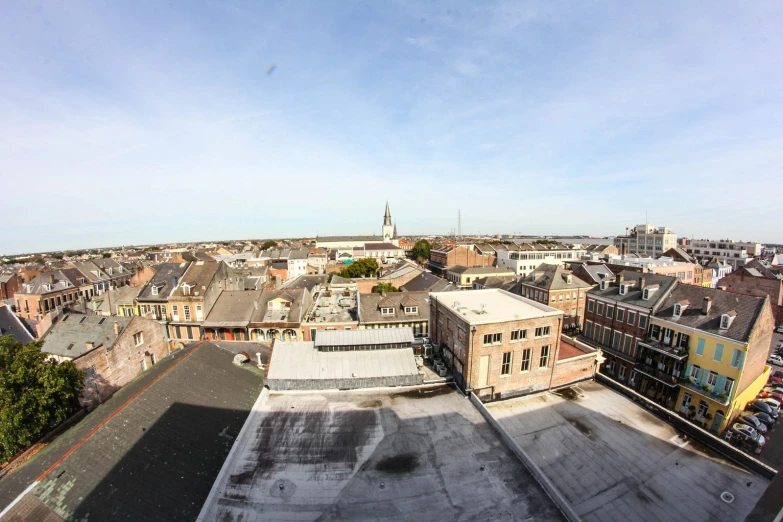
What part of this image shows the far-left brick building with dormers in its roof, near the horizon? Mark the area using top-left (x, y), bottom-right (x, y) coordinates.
top-left (14, 269), bottom-right (81, 321)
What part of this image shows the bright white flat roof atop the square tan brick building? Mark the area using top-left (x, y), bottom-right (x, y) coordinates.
top-left (430, 288), bottom-right (563, 325)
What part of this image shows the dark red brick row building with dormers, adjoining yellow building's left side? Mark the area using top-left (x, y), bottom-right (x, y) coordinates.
top-left (583, 271), bottom-right (677, 383)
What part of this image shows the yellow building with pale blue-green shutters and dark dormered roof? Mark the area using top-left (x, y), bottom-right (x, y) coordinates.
top-left (650, 285), bottom-right (774, 433)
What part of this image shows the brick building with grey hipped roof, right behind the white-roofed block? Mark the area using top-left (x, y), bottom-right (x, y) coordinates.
top-left (516, 263), bottom-right (592, 330)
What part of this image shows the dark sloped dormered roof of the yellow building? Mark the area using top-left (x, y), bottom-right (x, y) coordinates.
top-left (655, 285), bottom-right (769, 342)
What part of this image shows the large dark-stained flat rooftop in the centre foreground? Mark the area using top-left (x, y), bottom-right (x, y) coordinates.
top-left (198, 385), bottom-right (564, 521)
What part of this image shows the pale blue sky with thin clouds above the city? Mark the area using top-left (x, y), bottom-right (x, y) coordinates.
top-left (0, 0), bottom-right (783, 253)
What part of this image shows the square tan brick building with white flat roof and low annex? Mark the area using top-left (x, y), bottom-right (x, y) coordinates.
top-left (430, 289), bottom-right (596, 399)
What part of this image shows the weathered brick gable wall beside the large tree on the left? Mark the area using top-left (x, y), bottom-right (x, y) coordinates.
top-left (73, 317), bottom-right (169, 407)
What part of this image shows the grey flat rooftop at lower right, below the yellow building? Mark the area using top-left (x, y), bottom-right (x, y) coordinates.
top-left (487, 383), bottom-right (769, 522)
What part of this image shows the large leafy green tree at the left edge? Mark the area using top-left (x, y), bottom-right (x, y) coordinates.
top-left (0, 335), bottom-right (84, 461)
